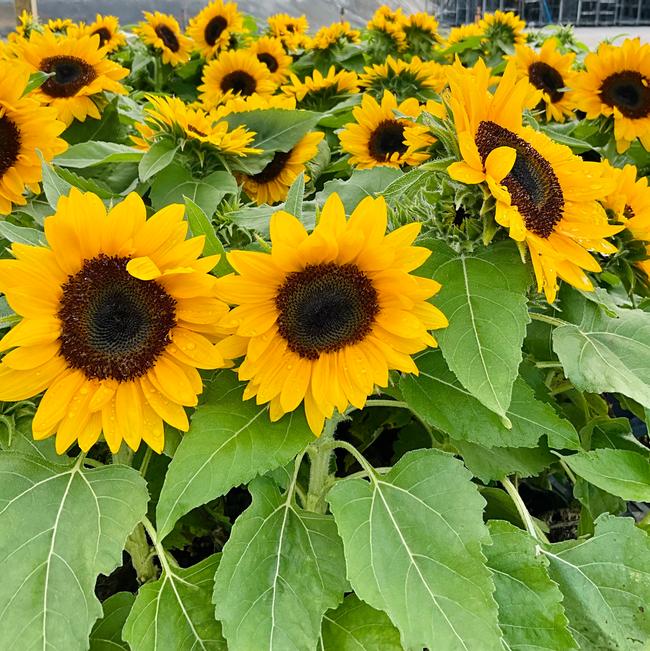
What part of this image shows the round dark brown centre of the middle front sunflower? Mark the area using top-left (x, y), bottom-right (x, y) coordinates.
top-left (275, 262), bottom-right (379, 360)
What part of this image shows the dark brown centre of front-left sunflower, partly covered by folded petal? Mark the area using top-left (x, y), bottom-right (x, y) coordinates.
top-left (58, 254), bottom-right (176, 382)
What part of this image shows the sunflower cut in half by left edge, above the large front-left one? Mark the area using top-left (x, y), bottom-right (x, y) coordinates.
top-left (0, 61), bottom-right (68, 215)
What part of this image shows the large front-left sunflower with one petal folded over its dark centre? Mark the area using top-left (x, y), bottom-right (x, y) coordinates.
top-left (0, 188), bottom-right (228, 454)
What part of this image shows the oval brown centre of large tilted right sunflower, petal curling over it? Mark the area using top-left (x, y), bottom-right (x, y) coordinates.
top-left (476, 121), bottom-right (564, 238)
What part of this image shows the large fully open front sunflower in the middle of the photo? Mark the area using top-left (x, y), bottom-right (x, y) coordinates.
top-left (217, 194), bottom-right (447, 436)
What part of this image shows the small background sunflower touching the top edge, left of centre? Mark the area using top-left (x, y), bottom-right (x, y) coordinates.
top-left (187, 0), bottom-right (244, 59)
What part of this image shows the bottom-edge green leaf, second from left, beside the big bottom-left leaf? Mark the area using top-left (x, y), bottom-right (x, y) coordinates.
top-left (123, 554), bottom-right (227, 651)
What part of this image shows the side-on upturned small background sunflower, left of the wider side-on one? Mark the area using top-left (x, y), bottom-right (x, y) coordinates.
top-left (282, 66), bottom-right (359, 111)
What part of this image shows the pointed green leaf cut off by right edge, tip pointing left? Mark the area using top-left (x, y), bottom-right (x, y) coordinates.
top-left (563, 448), bottom-right (650, 502)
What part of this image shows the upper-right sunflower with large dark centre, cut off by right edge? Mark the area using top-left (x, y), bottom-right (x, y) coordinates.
top-left (574, 38), bottom-right (650, 153)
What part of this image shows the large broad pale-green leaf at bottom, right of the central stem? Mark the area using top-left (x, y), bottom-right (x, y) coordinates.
top-left (328, 450), bottom-right (501, 651)
